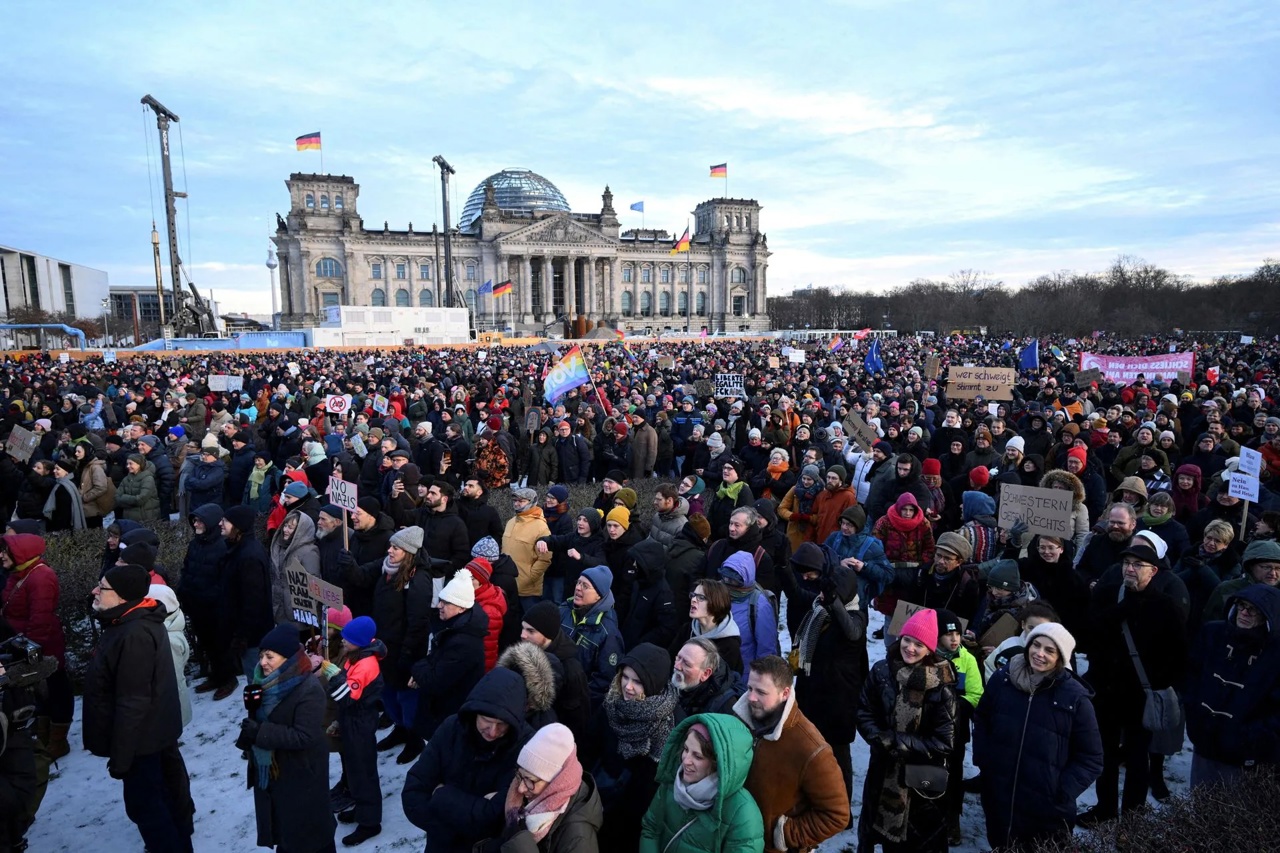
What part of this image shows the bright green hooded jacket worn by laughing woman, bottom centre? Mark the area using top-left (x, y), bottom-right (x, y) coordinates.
top-left (640, 713), bottom-right (764, 853)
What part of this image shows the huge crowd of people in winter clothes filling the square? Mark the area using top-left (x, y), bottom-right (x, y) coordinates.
top-left (0, 334), bottom-right (1280, 853)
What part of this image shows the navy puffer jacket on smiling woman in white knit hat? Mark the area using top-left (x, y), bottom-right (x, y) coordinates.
top-left (973, 658), bottom-right (1102, 848)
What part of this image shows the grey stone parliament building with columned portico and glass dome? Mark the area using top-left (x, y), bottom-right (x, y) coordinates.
top-left (273, 169), bottom-right (769, 336)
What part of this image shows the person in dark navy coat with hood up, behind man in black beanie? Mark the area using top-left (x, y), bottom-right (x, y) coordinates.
top-left (178, 503), bottom-right (232, 693)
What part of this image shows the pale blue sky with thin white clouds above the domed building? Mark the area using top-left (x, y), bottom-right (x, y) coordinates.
top-left (0, 0), bottom-right (1280, 313)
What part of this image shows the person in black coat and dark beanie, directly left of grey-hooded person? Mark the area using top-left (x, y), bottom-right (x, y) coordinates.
top-left (221, 506), bottom-right (275, 686)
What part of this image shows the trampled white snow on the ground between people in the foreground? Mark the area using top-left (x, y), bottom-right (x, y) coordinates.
top-left (27, 611), bottom-right (1190, 853)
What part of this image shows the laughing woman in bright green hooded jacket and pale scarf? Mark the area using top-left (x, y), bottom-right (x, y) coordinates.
top-left (640, 713), bottom-right (764, 853)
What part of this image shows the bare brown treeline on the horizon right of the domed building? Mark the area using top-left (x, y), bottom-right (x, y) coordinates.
top-left (769, 256), bottom-right (1280, 336)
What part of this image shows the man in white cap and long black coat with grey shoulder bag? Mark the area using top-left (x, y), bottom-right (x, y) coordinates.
top-left (1082, 530), bottom-right (1190, 825)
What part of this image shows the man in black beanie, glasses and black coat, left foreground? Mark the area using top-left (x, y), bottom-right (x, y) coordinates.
top-left (83, 565), bottom-right (193, 853)
